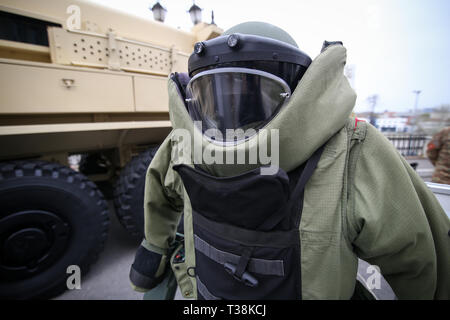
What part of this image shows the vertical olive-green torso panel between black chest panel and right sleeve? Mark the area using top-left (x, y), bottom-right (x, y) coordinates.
top-left (300, 119), bottom-right (358, 299)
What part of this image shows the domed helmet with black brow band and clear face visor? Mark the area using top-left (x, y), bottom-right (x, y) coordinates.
top-left (186, 22), bottom-right (311, 142)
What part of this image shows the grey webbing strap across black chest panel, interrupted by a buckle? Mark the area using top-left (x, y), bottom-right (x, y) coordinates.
top-left (194, 234), bottom-right (284, 277)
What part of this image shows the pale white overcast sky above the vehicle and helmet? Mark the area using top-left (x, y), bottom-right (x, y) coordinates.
top-left (90, 0), bottom-right (450, 112)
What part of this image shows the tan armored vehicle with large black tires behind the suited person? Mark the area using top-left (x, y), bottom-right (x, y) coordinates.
top-left (0, 0), bottom-right (221, 298)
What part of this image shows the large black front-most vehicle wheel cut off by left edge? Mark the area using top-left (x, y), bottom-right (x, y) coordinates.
top-left (0, 161), bottom-right (109, 299)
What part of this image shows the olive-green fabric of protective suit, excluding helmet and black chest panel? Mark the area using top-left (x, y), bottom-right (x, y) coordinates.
top-left (144, 45), bottom-right (450, 299)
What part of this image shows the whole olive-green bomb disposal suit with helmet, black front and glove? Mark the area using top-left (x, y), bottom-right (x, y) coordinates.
top-left (130, 22), bottom-right (450, 299)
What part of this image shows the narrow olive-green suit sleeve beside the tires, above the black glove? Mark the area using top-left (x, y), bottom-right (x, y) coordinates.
top-left (144, 135), bottom-right (183, 250)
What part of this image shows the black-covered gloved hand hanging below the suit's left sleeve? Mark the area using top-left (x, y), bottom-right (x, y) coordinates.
top-left (130, 239), bottom-right (168, 292)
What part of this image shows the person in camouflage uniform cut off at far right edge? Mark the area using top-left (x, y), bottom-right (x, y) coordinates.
top-left (427, 127), bottom-right (450, 184)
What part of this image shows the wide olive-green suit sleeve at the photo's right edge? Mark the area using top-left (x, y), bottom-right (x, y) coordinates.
top-left (347, 126), bottom-right (450, 299)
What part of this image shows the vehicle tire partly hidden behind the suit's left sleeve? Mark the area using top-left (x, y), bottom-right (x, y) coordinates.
top-left (114, 147), bottom-right (158, 238)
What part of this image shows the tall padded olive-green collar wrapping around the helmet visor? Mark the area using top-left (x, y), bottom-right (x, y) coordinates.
top-left (168, 45), bottom-right (356, 176)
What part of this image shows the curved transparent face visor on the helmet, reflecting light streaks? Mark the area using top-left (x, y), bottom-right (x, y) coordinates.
top-left (186, 68), bottom-right (291, 142)
